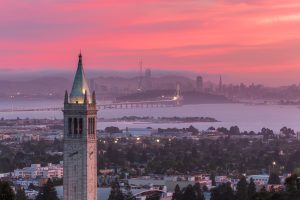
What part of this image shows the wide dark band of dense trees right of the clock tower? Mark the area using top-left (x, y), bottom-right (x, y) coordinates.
top-left (98, 133), bottom-right (300, 175)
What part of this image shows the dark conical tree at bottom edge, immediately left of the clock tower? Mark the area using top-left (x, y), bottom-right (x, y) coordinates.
top-left (36, 178), bottom-right (59, 200)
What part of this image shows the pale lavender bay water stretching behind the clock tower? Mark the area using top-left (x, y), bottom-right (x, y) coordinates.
top-left (0, 100), bottom-right (300, 132)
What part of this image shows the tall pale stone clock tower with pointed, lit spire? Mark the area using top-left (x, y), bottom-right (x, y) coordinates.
top-left (63, 53), bottom-right (97, 200)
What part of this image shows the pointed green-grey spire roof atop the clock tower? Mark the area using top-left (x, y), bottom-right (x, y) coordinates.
top-left (70, 52), bottom-right (91, 103)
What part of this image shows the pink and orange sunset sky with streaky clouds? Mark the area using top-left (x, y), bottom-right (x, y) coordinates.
top-left (0, 0), bottom-right (300, 85)
